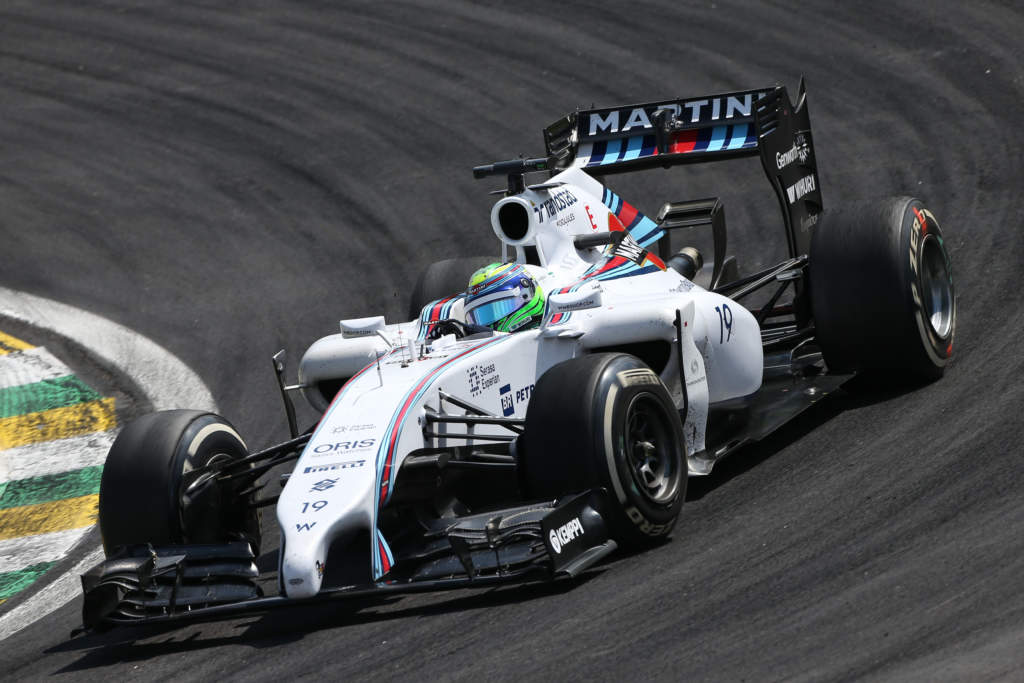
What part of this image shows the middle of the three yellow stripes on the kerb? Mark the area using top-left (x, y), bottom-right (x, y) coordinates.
top-left (0, 398), bottom-right (117, 451)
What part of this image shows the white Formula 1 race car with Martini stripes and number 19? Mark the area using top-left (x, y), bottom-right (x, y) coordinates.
top-left (82, 83), bottom-right (956, 628)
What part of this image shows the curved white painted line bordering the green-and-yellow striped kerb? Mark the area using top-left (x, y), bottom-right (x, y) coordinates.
top-left (0, 287), bottom-right (217, 640)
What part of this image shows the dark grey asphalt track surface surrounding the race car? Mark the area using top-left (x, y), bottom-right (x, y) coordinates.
top-left (0, 0), bottom-right (1024, 680)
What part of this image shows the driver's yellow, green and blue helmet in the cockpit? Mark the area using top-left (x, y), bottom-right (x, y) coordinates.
top-left (465, 263), bottom-right (544, 332)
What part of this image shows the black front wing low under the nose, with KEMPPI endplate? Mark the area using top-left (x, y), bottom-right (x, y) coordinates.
top-left (82, 489), bottom-right (616, 630)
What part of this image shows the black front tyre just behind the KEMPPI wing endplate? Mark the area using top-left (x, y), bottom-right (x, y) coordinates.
top-left (518, 353), bottom-right (687, 547)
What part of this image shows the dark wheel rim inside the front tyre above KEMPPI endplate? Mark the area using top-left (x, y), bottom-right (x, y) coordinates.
top-left (626, 394), bottom-right (679, 505)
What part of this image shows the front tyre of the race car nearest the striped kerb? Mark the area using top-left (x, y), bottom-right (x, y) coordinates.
top-left (99, 411), bottom-right (260, 556)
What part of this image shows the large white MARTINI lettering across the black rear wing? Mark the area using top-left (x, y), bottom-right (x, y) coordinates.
top-left (581, 91), bottom-right (762, 136)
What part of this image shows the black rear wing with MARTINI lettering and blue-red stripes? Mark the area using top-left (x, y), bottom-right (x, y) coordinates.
top-left (544, 79), bottom-right (822, 257)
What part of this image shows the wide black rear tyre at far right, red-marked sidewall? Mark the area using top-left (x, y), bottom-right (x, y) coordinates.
top-left (808, 197), bottom-right (956, 381)
